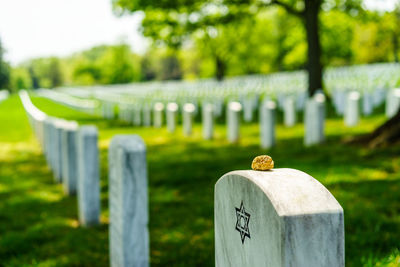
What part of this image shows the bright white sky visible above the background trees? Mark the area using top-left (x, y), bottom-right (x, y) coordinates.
top-left (0, 0), bottom-right (397, 65)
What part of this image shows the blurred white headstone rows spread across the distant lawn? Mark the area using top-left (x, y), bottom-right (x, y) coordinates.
top-left (39, 64), bottom-right (400, 148)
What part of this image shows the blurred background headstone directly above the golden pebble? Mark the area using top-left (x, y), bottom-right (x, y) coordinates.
top-left (259, 100), bottom-right (276, 148)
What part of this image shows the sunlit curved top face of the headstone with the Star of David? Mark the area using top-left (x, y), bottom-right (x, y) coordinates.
top-left (216, 168), bottom-right (343, 216)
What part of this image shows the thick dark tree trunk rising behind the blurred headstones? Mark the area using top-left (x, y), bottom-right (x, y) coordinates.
top-left (304, 0), bottom-right (322, 96)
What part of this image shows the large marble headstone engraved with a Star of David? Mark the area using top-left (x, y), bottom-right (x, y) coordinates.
top-left (214, 169), bottom-right (344, 267)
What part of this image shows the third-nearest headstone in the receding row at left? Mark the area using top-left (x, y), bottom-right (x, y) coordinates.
top-left (61, 121), bottom-right (78, 195)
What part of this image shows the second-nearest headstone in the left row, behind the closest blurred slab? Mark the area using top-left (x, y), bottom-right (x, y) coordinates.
top-left (78, 126), bottom-right (100, 226)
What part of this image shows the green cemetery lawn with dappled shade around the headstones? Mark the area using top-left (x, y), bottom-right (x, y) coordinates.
top-left (0, 95), bottom-right (400, 266)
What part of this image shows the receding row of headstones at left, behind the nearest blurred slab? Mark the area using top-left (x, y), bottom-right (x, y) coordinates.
top-left (20, 91), bottom-right (100, 226)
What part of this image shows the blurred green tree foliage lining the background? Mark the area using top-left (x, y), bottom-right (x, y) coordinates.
top-left (0, 0), bottom-right (400, 90)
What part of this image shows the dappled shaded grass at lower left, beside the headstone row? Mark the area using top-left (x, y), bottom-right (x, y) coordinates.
top-left (0, 150), bottom-right (108, 266)
